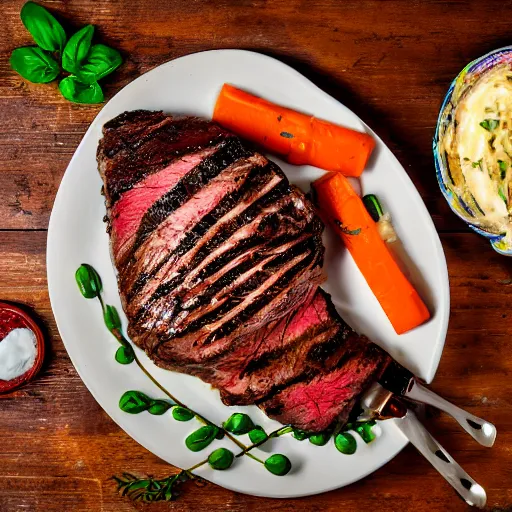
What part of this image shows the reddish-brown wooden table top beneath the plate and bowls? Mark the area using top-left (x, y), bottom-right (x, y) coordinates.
top-left (0, 0), bottom-right (512, 512)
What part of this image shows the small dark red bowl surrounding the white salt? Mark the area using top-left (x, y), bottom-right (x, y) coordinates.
top-left (0, 302), bottom-right (44, 394)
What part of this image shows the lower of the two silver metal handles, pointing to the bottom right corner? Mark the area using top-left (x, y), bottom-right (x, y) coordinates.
top-left (395, 409), bottom-right (487, 508)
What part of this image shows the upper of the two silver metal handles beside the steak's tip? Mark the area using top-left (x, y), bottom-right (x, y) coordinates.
top-left (403, 379), bottom-right (496, 448)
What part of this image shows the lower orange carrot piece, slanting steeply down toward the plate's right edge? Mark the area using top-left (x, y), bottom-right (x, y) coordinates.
top-left (313, 173), bottom-right (430, 334)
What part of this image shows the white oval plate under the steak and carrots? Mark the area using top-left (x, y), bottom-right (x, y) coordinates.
top-left (47, 50), bottom-right (449, 497)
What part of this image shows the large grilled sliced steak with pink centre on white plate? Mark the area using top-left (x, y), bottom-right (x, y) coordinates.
top-left (98, 111), bottom-right (388, 432)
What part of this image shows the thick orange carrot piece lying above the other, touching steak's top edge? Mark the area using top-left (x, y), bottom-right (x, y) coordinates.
top-left (213, 84), bottom-right (375, 176)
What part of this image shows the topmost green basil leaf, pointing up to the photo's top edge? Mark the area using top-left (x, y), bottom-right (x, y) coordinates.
top-left (20, 2), bottom-right (66, 52)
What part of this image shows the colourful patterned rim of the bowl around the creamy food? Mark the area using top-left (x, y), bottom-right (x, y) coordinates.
top-left (433, 46), bottom-right (512, 256)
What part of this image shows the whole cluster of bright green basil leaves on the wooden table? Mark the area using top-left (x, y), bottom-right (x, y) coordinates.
top-left (10, 2), bottom-right (123, 103)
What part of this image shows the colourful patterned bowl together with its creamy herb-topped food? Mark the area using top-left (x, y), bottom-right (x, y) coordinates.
top-left (434, 47), bottom-right (512, 255)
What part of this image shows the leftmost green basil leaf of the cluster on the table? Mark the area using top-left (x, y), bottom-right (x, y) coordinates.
top-left (9, 46), bottom-right (60, 84)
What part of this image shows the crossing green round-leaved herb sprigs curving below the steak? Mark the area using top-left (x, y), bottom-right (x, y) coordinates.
top-left (75, 263), bottom-right (375, 502)
